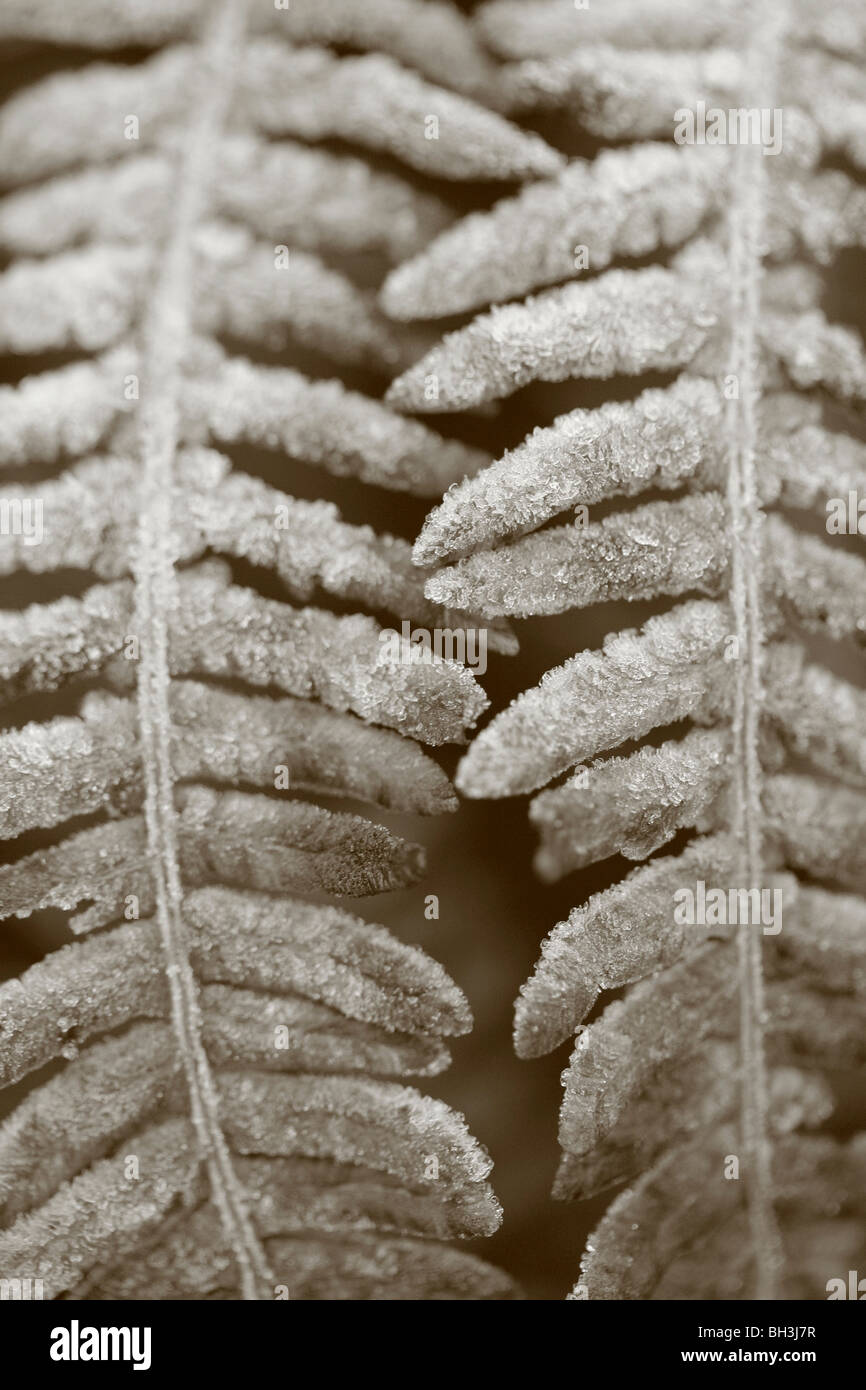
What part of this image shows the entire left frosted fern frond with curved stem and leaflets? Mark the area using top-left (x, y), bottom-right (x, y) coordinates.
top-left (0, 0), bottom-right (563, 1298)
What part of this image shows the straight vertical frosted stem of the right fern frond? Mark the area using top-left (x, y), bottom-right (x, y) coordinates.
top-left (727, 15), bottom-right (783, 1300)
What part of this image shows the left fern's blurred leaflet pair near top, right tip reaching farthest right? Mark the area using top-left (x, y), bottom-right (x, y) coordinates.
top-left (0, 39), bottom-right (564, 183)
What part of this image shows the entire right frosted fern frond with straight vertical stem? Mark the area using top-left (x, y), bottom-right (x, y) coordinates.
top-left (382, 0), bottom-right (866, 1300)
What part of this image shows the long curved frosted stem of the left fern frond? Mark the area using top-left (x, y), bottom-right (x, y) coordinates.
top-left (127, 0), bottom-right (272, 1298)
